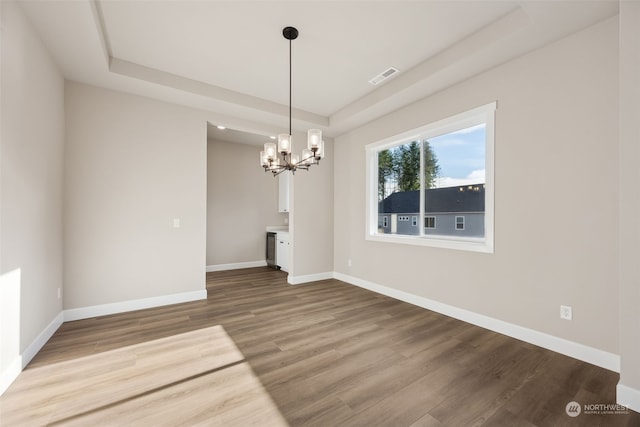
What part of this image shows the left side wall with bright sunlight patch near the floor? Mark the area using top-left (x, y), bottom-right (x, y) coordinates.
top-left (0, 1), bottom-right (64, 393)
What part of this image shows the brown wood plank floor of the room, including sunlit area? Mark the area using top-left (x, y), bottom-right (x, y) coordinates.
top-left (0, 268), bottom-right (640, 426)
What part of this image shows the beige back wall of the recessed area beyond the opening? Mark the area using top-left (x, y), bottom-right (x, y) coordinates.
top-left (207, 140), bottom-right (288, 266)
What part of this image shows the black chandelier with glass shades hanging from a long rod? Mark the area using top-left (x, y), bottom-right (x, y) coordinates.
top-left (260, 27), bottom-right (324, 176)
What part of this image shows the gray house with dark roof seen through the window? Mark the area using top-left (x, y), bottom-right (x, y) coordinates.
top-left (378, 184), bottom-right (485, 237)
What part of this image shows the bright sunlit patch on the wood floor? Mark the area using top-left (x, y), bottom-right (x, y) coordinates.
top-left (0, 325), bottom-right (287, 426)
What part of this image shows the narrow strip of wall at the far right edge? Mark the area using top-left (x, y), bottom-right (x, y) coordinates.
top-left (618, 1), bottom-right (640, 412)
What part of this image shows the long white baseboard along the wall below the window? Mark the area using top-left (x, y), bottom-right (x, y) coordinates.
top-left (334, 272), bottom-right (620, 372)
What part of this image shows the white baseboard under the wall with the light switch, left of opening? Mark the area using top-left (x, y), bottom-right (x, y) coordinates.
top-left (64, 289), bottom-right (207, 322)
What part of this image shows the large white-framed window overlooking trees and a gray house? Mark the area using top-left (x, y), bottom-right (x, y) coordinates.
top-left (366, 102), bottom-right (496, 252)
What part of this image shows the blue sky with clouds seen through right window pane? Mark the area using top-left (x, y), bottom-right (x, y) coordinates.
top-left (429, 124), bottom-right (485, 187)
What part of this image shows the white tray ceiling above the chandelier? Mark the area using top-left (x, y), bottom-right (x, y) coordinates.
top-left (21, 0), bottom-right (618, 140)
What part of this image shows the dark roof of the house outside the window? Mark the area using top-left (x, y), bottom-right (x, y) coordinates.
top-left (378, 184), bottom-right (485, 213)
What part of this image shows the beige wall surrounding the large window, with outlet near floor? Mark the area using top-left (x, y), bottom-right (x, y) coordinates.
top-left (334, 19), bottom-right (619, 354)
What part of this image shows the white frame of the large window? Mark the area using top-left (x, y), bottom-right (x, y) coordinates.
top-left (365, 102), bottom-right (497, 253)
